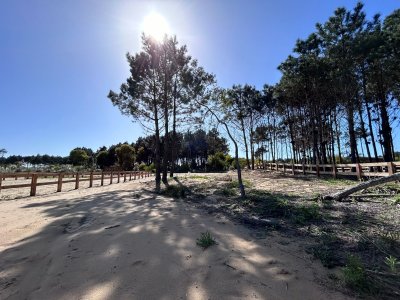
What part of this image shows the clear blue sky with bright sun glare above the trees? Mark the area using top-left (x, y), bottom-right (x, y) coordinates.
top-left (0, 0), bottom-right (400, 156)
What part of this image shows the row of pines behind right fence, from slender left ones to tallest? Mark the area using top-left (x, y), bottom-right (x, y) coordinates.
top-left (216, 3), bottom-right (400, 169)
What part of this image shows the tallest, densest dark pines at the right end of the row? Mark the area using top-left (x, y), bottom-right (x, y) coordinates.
top-left (275, 3), bottom-right (400, 163)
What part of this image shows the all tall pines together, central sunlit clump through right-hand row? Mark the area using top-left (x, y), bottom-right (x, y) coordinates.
top-left (108, 3), bottom-right (400, 195)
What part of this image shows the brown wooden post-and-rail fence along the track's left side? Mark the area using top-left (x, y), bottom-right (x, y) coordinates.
top-left (0, 171), bottom-right (152, 196)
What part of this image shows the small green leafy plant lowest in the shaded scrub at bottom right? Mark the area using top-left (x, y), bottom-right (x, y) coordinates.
top-left (342, 255), bottom-right (368, 292)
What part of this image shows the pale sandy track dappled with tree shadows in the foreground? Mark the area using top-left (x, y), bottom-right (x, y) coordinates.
top-left (0, 178), bottom-right (352, 299)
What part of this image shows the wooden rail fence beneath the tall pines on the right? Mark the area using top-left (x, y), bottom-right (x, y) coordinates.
top-left (265, 162), bottom-right (400, 179)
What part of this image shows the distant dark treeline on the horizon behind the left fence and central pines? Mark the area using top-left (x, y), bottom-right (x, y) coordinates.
top-left (0, 129), bottom-right (231, 171)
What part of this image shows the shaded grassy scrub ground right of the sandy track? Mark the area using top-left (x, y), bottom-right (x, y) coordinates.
top-left (177, 172), bottom-right (400, 299)
